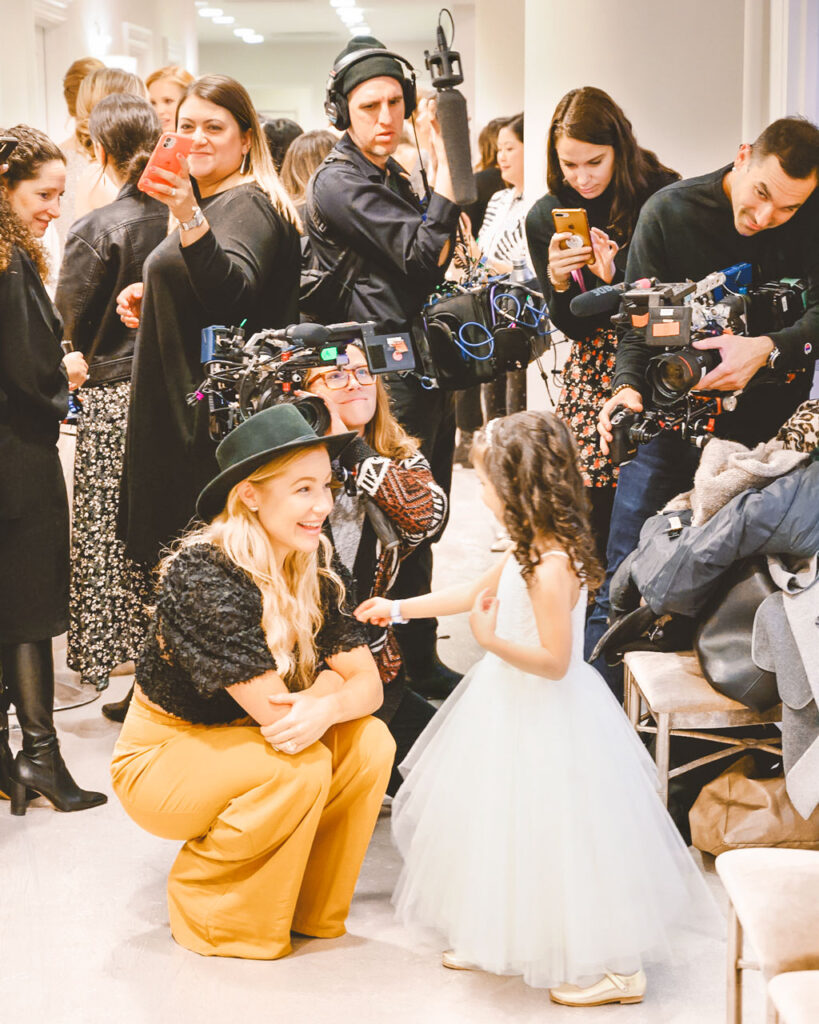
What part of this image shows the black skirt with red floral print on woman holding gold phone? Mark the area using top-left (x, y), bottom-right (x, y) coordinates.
top-left (557, 328), bottom-right (617, 487)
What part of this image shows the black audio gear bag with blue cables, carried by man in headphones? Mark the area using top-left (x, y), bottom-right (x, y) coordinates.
top-left (413, 264), bottom-right (551, 391)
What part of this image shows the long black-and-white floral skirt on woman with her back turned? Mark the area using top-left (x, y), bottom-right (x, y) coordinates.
top-left (68, 382), bottom-right (154, 690)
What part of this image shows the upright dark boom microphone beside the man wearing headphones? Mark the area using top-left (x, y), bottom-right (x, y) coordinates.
top-left (424, 11), bottom-right (478, 206)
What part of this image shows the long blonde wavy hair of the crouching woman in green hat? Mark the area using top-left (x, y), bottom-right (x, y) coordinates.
top-left (159, 449), bottom-right (345, 690)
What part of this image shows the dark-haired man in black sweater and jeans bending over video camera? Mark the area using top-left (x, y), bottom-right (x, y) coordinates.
top-left (586, 117), bottom-right (819, 688)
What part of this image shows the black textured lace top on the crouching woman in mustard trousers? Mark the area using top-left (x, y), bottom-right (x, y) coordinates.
top-left (136, 544), bottom-right (368, 725)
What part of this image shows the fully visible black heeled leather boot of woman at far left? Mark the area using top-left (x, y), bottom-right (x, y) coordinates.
top-left (0, 640), bottom-right (107, 814)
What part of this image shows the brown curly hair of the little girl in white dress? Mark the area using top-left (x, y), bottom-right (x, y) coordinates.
top-left (473, 411), bottom-right (604, 591)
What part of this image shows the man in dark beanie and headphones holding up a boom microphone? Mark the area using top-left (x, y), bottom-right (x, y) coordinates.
top-left (305, 37), bottom-right (459, 696)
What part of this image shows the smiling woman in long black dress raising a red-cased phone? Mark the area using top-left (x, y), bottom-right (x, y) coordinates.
top-left (119, 75), bottom-right (300, 565)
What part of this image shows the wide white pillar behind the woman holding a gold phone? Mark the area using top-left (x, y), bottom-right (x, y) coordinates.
top-left (525, 0), bottom-right (755, 200)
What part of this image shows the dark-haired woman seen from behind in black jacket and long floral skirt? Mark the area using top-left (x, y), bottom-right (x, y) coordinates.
top-left (55, 93), bottom-right (168, 689)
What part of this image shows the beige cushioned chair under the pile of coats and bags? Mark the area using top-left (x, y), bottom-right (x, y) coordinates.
top-left (623, 650), bottom-right (782, 805)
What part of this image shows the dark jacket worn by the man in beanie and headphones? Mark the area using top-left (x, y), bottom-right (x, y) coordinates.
top-left (305, 133), bottom-right (460, 331)
